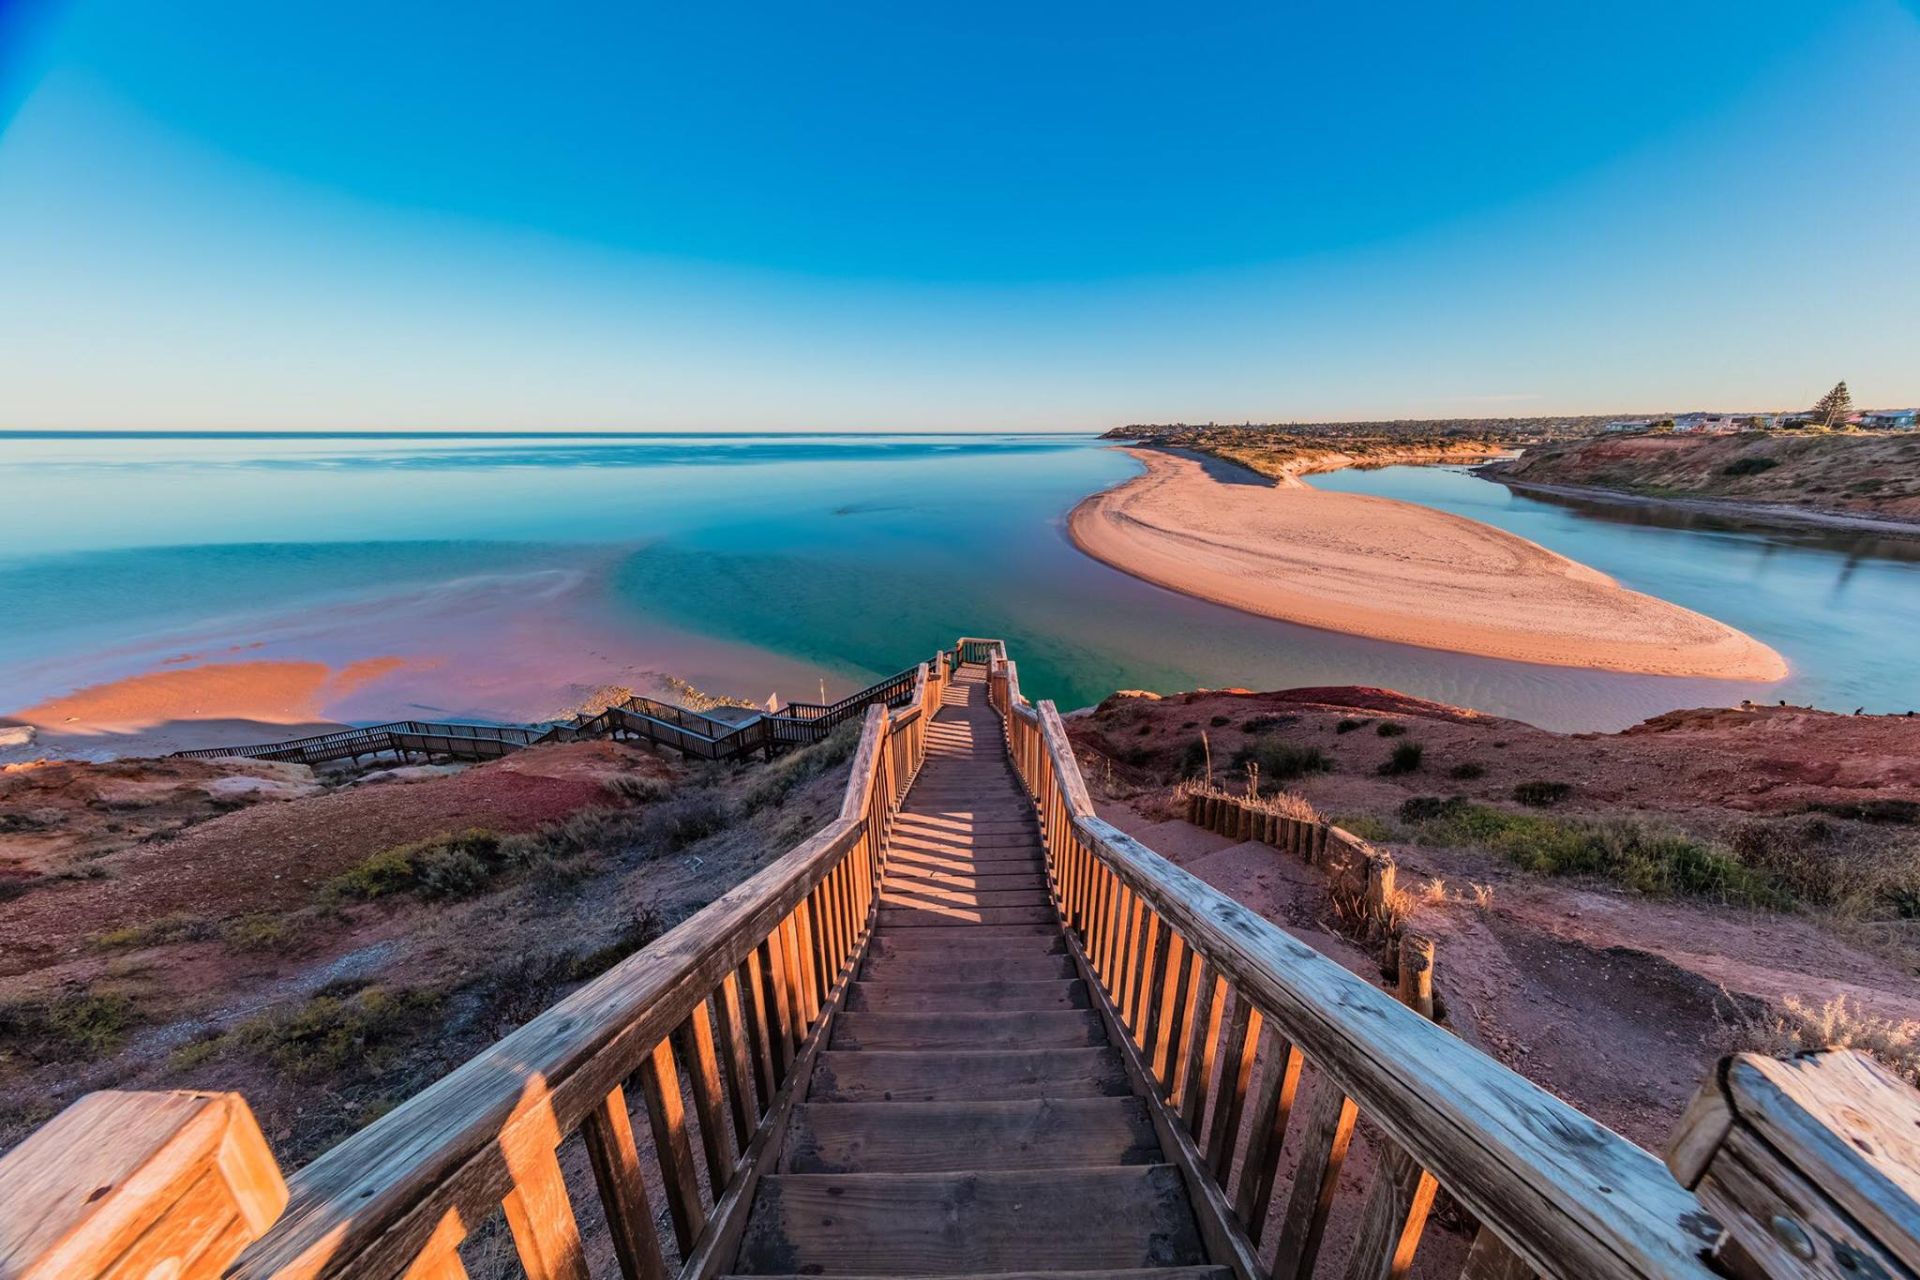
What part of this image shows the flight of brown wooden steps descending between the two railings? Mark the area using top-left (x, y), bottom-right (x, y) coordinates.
top-left (733, 666), bottom-right (1229, 1280)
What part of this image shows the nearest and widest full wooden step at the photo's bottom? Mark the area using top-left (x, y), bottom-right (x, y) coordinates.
top-left (735, 1165), bottom-right (1206, 1276)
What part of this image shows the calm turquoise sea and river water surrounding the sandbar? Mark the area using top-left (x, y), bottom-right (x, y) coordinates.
top-left (0, 436), bottom-right (1920, 727)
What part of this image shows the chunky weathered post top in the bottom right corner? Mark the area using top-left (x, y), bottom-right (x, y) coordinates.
top-left (1667, 1052), bottom-right (1920, 1280)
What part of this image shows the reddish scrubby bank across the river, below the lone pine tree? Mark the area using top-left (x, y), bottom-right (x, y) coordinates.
top-left (1486, 432), bottom-right (1920, 522)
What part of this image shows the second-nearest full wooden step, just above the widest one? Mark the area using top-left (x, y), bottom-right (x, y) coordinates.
top-left (783, 1098), bottom-right (1165, 1173)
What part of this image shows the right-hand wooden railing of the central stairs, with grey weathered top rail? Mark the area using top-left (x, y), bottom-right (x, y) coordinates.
top-left (989, 649), bottom-right (1722, 1280)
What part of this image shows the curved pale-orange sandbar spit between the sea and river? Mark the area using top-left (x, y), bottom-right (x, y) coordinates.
top-left (1068, 449), bottom-right (1788, 681)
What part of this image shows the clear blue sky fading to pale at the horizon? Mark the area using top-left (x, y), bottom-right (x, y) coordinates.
top-left (0, 0), bottom-right (1920, 430)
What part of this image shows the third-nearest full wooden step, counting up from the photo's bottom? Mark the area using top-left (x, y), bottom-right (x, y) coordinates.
top-left (806, 1048), bottom-right (1133, 1102)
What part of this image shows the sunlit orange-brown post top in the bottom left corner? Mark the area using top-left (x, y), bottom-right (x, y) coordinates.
top-left (0, 1092), bottom-right (286, 1280)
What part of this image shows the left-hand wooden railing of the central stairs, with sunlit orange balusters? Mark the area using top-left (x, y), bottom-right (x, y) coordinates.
top-left (230, 664), bottom-right (943, 1280)
